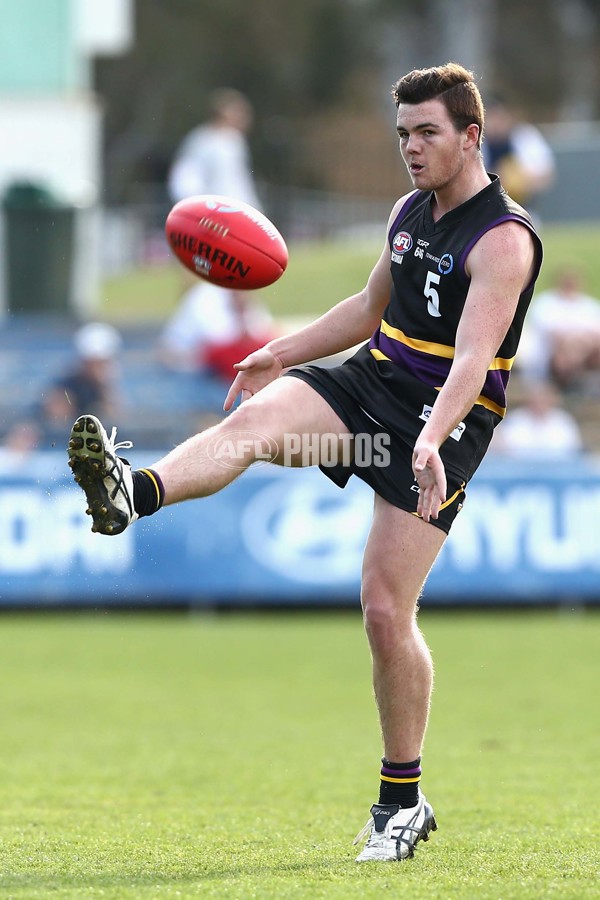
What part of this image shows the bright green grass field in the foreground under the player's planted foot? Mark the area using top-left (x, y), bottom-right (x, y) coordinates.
top-left (0, 610), bottom-right (600, 900)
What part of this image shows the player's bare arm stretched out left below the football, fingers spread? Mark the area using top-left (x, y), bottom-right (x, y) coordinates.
top-left (224, 197), bottom-right (406, 410)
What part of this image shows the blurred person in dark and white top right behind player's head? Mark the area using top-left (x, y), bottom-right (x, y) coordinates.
top-left (482, 96), bottom-right (555, 212)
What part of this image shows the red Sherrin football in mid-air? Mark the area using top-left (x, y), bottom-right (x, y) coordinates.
top-left (165, 194), bottom-right (288, 290)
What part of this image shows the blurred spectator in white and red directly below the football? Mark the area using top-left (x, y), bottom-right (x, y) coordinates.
top-left (160, 281), bottom-right (276, 381)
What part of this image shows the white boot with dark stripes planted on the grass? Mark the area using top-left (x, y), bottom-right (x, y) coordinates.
top-left (354, 791), bottom-right (437, 862)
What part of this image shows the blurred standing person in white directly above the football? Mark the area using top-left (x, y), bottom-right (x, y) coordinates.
top-left (168, 88), bottom-right (259, 207)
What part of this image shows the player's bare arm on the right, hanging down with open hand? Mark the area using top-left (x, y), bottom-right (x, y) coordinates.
top-left (413, 222), bottom-right (535, 521)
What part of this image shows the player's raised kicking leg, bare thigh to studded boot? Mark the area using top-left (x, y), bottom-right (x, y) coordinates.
top-left (69, 378), bottom-right (350, 534)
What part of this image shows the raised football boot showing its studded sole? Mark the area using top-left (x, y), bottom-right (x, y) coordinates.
top-left (68, 414), bottom-right (138, 534)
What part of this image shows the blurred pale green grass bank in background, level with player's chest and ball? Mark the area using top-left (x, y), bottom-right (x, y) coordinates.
top-left (101, 224), bottom-right (600, 322)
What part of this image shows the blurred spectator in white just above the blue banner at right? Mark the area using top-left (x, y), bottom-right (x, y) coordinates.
top-left (492, 381), bottom-right (583, 461)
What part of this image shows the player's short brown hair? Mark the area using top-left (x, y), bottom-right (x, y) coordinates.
top-left (392, 62), bottom-right (484, 147)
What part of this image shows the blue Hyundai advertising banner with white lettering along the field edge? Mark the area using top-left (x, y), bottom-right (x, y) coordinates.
top-left (0, 453), bottom-right (600, 606)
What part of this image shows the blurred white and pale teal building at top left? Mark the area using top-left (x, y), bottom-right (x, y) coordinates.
top-left (0, 0), bottom-right (133, 313)
